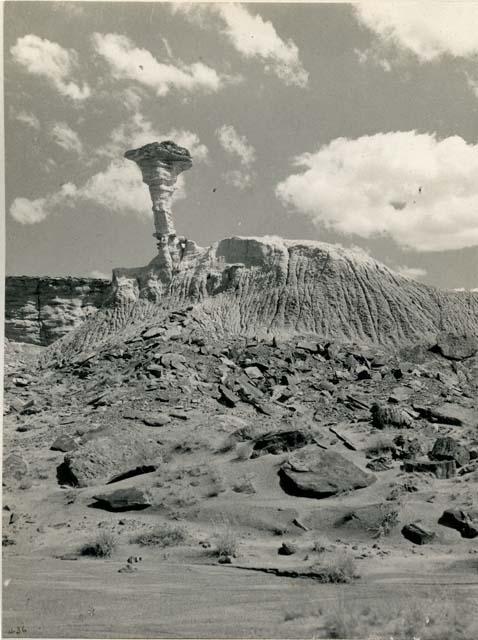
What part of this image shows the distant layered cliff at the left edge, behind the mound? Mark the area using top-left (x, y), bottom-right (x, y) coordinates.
top-left (5, 276), bottom-right (110, 346)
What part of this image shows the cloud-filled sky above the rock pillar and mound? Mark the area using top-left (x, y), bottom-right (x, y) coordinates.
top-left (4, 0), bottom-right (478, 290)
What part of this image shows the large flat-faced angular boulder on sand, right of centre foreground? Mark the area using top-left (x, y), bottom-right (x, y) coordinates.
top-left (279, 445), bottom-right (376, 498)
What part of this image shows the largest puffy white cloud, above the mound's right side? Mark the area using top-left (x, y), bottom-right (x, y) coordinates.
top-left (276, 131), bottom-right (478, 251)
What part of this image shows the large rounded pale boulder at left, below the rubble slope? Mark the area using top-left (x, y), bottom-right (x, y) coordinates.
top-left (57, 428), bottom-right (161, 487)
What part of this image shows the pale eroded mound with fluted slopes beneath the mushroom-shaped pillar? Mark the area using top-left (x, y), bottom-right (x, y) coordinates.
top-left (42, 237), bottom-right (478, 364)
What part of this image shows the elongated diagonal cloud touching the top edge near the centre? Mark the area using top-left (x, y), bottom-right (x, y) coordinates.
top-left (173, 3), bottom-right (309, 87)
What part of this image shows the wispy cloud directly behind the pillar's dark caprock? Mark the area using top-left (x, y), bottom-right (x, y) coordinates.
top-left (97, 112), bottom-right (208, 161)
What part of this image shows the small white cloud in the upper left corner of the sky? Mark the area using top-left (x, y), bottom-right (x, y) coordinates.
top-left (10, 34), bottom-right (91, 101)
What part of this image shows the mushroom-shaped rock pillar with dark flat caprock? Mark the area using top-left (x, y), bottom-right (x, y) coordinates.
top-left (124, 140), bottom-right (193, 271)
